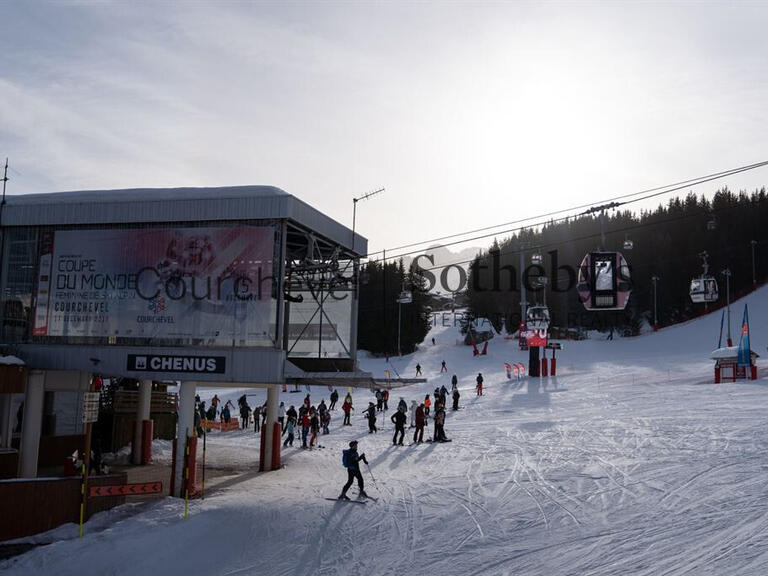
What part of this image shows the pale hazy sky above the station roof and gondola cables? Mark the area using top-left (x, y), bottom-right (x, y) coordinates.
top-left (0, 1), bottom-right (768, 258)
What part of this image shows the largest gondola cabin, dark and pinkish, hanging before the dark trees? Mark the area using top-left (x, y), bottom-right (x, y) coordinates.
top-left (576, 252), bottom-right (632, 311)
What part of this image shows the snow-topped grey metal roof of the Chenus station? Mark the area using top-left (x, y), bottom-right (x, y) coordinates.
top-left (2, 186), bottom-right (368, 255)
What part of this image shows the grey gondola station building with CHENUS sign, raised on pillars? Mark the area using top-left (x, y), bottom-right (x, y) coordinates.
top-left (0, 186), bottom-right (374, 520)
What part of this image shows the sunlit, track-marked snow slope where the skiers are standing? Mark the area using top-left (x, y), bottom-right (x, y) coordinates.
top-left (0, 289), bottom-right (768, 576)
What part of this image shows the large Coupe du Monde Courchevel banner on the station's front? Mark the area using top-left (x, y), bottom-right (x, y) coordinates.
top-left (33, 226), bottom-right (274, 345)
